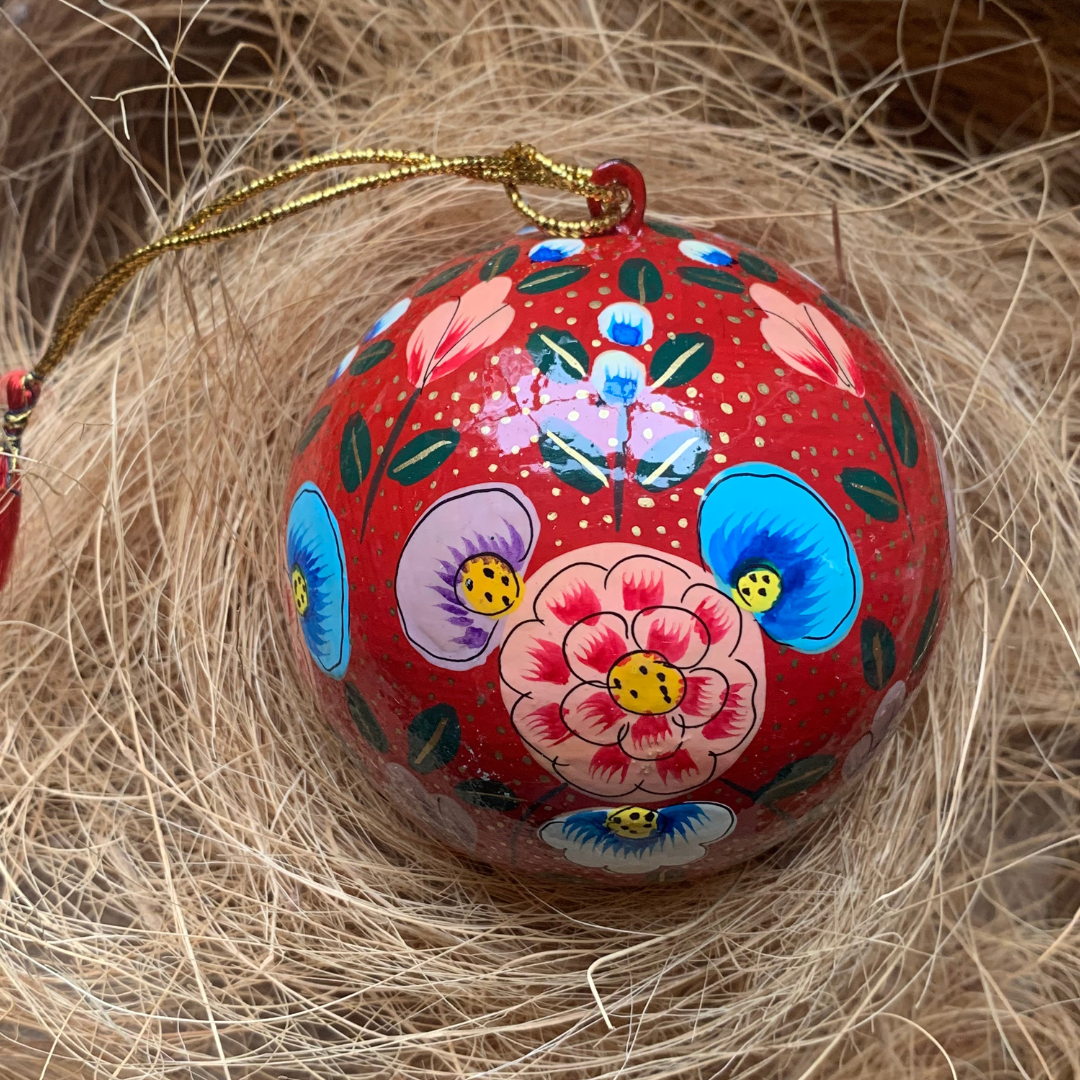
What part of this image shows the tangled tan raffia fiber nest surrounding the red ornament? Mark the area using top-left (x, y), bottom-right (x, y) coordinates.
top-left (0, 0), bottom-right (1080, 1080)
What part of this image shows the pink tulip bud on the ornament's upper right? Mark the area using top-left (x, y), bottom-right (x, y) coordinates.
top-left (750, 282), bottom-right (866, 397)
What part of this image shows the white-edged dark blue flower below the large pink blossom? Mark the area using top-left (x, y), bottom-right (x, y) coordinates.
top-left (539, 802), bottom-right (735, 874)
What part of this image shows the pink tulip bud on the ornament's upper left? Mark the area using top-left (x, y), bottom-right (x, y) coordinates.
top-left (406, 278), bottom-right (514, 387)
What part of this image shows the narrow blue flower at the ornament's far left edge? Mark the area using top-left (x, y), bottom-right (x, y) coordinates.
top-left (285, 482), bottom-right (349, 678)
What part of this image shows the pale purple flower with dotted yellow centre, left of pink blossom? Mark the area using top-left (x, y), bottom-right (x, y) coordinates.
top-left (394, 484), bottom-right (540, 670)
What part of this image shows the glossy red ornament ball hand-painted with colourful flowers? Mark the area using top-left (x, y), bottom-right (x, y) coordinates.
top-left (283, 203), bottom-right (955, 885)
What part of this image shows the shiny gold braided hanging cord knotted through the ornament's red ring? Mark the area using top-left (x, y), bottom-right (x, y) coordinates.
top-left (29, 143), bottom-right (629, 393)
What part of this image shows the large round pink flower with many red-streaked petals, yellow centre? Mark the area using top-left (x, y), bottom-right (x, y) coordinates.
top-left (499, 543), bottom-right (765, 802)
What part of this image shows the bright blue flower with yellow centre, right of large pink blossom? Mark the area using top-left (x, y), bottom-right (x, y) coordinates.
top-left (698, 461), bottom-right (863, 652)
